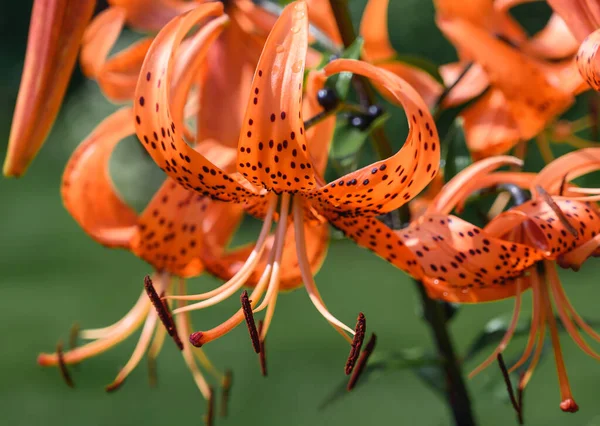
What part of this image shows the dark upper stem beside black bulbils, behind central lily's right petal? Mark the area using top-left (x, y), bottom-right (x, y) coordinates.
top-left (329, 0), bottom-right (393, 159)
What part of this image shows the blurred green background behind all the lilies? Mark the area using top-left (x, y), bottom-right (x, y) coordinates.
top-left (0, 0), bottom-right (600, 426)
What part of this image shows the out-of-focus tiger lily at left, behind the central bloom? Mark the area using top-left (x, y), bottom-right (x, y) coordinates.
top-left (38, 108), bottom-right (248, 400)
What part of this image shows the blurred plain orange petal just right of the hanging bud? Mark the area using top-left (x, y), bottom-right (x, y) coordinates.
top-left (79, 7), bottom-right (127, 78)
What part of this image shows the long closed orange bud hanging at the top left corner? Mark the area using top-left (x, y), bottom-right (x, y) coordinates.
top-left (4, 0), bottom-right (96, 176)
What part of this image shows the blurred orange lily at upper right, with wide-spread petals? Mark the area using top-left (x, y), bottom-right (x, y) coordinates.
top-left (438, 17), bottom-right (582, 158)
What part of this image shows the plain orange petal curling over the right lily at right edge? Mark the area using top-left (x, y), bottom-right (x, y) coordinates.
top-left (530, 148), bottom-right (600, 196)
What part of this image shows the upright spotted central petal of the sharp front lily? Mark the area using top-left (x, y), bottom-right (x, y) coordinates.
top-left (238, 2), bottom-right (315, 191)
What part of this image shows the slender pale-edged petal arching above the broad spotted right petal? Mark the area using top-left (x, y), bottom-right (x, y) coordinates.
top-left (426, 156), bottom-right (523, 214)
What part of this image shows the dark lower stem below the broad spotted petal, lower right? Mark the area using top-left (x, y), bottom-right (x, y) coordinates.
top-left (415, 281), bottom-right (476, 426)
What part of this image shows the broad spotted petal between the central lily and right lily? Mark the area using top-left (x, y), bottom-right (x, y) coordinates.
top-left (410, 215), bottom-right (541, 303)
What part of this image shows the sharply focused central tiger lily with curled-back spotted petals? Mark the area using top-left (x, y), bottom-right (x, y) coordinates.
top-left (134, 1), bottom-right (439, 356)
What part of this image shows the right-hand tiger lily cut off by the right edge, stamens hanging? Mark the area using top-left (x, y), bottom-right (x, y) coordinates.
top-left (428, 149), bottom-right (600, 412)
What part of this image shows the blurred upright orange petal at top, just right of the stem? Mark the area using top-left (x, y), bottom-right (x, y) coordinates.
top-left (360, 0), bottom-right (396, 62)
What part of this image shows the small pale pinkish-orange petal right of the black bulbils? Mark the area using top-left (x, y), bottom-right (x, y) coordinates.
top-left (440, 62), bottom-right (490, 108)
